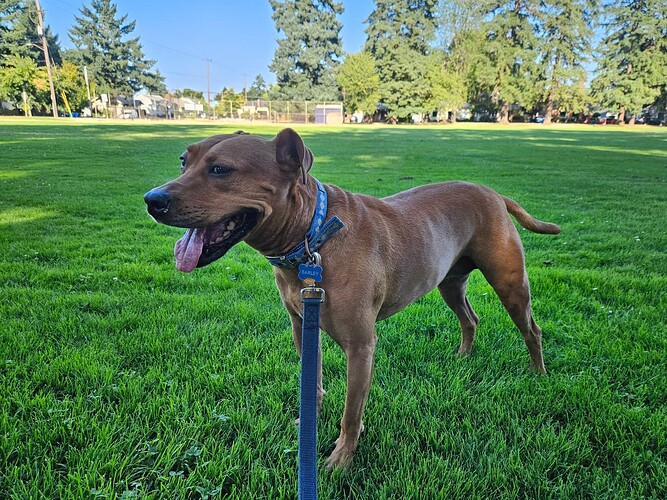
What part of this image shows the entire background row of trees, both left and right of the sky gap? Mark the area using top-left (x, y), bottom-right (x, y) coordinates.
top-left (0, 0), bottom-right (667, 122)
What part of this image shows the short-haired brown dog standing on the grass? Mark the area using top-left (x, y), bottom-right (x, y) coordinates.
top-left (145, 129), bottom-right (560, 468)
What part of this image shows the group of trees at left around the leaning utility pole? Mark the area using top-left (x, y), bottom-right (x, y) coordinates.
top-left (0, 0), bottom-right (166, 115)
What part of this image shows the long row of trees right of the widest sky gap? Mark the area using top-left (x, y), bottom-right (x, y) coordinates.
top-left (270, 0), bottom-right (667, 123)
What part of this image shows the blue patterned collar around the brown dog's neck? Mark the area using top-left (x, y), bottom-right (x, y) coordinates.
top-left (266, 179), bottom-right (345, 269)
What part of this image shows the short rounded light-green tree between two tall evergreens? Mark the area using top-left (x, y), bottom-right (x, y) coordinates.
top-left (336, 52), bottom-right (380, 115)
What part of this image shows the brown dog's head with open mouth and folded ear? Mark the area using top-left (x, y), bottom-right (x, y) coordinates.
top-left (144, 128), bottom-right (313, 272)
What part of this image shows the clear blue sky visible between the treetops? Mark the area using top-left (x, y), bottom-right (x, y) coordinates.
top-left (40, 0), bottom-right (374, 93)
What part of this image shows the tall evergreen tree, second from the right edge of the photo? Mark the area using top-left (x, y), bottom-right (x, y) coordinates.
top-left (538, 0), bottom-right (596, 125)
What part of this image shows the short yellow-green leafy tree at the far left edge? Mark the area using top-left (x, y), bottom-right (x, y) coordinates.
top-left (0, 55), bottom-right (50, 116)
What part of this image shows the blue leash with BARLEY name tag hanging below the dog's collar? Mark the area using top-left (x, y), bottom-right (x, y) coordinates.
top-left (299, 253), bottom-right (324, 500)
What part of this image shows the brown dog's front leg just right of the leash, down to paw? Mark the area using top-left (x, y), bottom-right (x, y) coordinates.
top-left (325, 325), bottom-right (377, 470)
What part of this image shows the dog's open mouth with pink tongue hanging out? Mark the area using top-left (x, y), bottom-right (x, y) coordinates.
top-left (174, 210), bottom-right (259, 273)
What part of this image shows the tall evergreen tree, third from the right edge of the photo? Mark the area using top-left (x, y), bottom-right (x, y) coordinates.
top-left (474, 0), bottom-right (539, 123)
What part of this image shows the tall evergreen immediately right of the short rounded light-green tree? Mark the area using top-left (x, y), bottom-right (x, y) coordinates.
top-left (365, 0), bottom-right (437, 119)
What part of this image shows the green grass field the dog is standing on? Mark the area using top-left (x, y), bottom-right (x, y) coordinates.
top-left (0, 119), bottom-right (667, 499)
